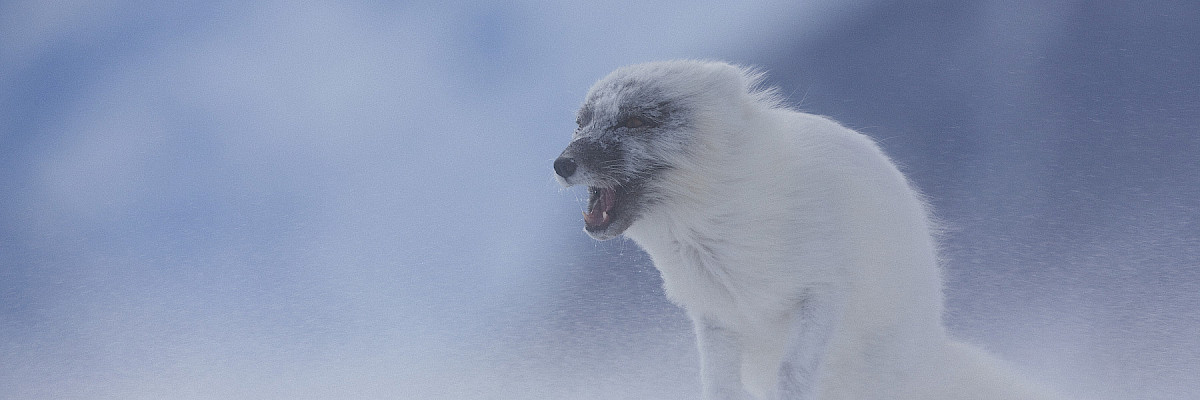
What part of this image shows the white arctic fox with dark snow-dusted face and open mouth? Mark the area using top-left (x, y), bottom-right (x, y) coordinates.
top-left (553, 61), bottom-right (1048, 400)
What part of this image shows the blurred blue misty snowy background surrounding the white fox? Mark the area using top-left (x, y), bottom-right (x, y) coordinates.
top-left (0, 0), bottom-right (1200, 399)
